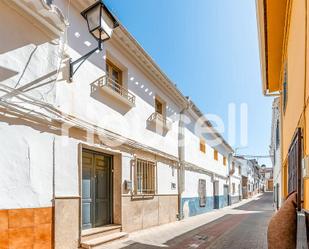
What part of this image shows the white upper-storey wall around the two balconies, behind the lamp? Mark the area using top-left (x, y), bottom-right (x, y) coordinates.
top-left (53, 1), bottom-right (180, 156)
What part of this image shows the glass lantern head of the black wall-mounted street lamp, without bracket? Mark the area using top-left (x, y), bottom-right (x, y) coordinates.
top-left (81, 0), bottom-right (118, 41)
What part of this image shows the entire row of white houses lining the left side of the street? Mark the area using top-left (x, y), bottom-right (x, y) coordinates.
top-left (0, 0), bottom-right (241, 249)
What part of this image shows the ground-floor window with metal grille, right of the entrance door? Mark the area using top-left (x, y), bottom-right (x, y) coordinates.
top-left (135, 159), bottom-right (156, 194)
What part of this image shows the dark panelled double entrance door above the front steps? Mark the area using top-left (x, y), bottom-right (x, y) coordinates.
top-left (82, 150), bottom-right (112, 229)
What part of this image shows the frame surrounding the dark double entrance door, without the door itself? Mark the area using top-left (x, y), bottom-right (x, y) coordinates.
top-left (78, 143), bottom-right (115, 235)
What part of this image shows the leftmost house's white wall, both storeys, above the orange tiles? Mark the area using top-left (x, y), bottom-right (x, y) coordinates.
top-left (0, 2), bottom-right (62, 209)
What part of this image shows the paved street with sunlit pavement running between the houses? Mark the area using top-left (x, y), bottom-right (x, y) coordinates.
top-left (102, 192), bottom-right (273, 249)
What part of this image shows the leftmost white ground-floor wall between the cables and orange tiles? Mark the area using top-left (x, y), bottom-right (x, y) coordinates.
top-left (0, 122), bottom-right (53, 209)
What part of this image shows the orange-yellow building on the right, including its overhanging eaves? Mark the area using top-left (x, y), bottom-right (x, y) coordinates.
top-left (257, 0), bottom-right (309, 210)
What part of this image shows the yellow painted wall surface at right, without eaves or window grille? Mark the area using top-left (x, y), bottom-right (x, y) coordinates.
top-left (280, 0), bottom-right (309, 210)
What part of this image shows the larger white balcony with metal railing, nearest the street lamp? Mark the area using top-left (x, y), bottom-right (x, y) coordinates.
top-left (91, 75), bottom-right (135, 107)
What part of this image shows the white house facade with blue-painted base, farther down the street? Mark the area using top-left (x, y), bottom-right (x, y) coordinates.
top-left (181, 101), bottom-right (233, 217)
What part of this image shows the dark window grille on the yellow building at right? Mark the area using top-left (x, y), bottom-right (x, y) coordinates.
top-left (288, 128), bottom-right (302, 210)
